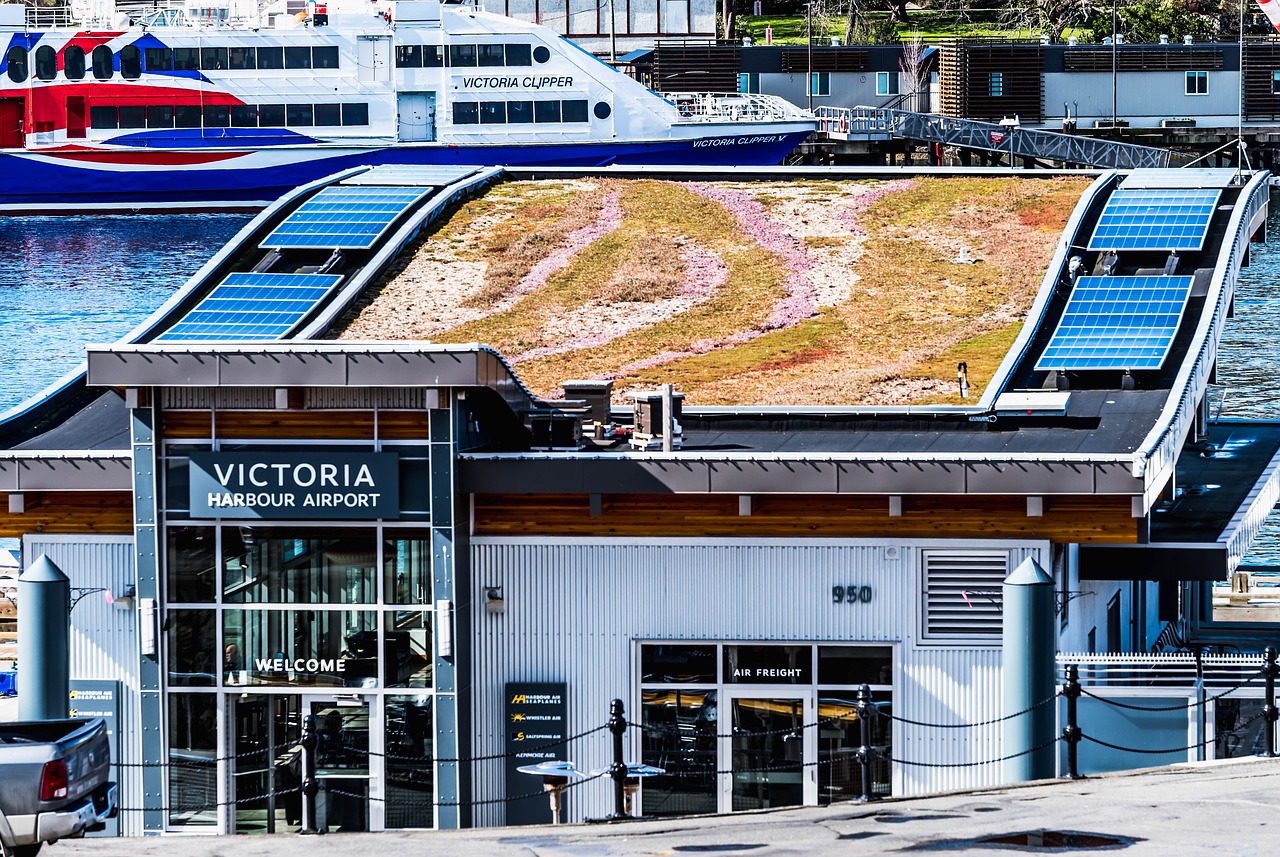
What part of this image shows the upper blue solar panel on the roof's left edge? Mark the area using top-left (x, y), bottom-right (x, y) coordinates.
top-left (260, 184), bottom-right (431, 249)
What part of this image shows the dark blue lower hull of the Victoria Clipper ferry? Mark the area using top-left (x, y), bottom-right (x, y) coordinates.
top-left (0, 134), bottom-right (809, 214)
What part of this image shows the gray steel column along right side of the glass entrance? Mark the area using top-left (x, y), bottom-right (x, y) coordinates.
top-left (429, 399), bottom-right (462, 829)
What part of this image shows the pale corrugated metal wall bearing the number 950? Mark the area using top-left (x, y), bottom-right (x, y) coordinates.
top-left (471, 539), bottom-right (1048, 825)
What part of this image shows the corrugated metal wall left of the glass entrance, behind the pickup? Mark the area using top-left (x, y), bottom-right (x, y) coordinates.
top-left (25, 535), bottom-right (145, 835)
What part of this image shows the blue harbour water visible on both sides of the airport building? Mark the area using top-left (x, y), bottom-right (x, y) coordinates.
top-left (0, 194), bottom-right (1280, 567)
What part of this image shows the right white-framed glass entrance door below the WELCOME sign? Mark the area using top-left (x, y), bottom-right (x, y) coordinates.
top-left (305, 697), bottom-right (374, 833)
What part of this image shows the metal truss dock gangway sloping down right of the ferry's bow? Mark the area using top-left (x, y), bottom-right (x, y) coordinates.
top-left (814, 107), bottom-right (1179, 170)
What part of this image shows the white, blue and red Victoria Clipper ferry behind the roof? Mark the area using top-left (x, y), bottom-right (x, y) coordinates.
top-left (0, 0), bottom-right (815, 214)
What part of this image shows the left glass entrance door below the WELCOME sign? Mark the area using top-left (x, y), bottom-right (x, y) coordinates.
top-left (229, 693), bottom-right (302, 833)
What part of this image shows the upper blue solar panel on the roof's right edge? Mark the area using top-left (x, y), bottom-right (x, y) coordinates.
top-left (1089, 188), bottom-right (1222, 251)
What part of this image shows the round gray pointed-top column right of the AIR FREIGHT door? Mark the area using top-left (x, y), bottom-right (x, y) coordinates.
top-left (1002, 556), bottom-right (1057, 783)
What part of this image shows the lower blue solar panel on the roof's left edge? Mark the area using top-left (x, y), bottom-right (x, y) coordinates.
top-left (156, 272), bottom-right (342, 342)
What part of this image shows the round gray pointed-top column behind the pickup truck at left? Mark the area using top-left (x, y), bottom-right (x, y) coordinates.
top-left (18, 554), bottom-right (72, 720)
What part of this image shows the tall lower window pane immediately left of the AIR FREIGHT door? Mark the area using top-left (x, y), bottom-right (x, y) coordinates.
top-left (640, 688), bottom-right (717, 815)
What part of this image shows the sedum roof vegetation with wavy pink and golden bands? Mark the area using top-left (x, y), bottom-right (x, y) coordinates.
top-left (335, 178), bottom-right (1089, 405)
